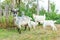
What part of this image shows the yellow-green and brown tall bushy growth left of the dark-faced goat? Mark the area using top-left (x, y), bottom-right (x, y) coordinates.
top-left (0, 15), bottom-right (14, 28)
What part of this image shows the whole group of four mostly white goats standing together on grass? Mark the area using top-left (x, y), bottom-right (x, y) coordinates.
top-left (14, 14), bottom-right (57, 33)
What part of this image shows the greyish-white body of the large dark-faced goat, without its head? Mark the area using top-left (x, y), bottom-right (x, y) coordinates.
top-left (14, 15), bottom-right (32, 32)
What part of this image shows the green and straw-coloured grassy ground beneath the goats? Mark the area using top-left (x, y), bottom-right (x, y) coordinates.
top-left (0, 26), bottom-right (60, 40)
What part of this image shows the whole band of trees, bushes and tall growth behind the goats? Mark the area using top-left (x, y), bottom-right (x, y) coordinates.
top-left (0, 0), bottom-right (60, 28)
